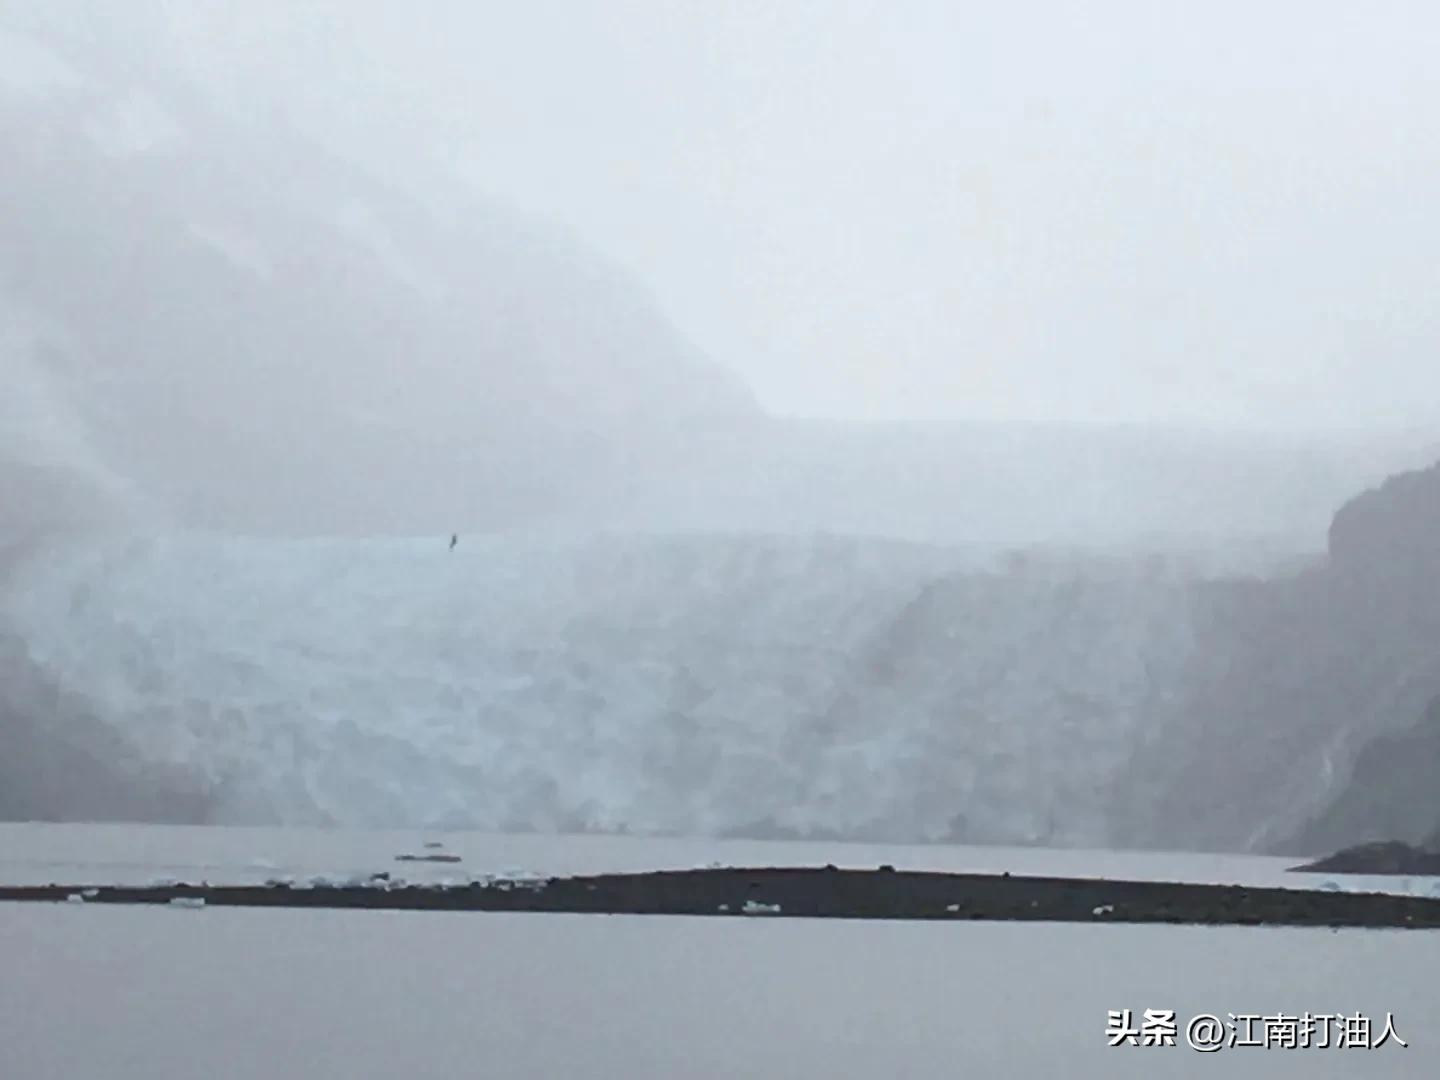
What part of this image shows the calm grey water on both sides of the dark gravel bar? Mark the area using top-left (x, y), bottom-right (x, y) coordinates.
top-left (0, 825), bottom-right (1440, 1080)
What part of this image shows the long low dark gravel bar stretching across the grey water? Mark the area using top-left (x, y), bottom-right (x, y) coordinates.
top-left (0, 867), bottom-right (1440, 929)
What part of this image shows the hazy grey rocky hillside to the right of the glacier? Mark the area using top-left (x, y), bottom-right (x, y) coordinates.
top-left (1115, 457), bottom-right (1440, 854)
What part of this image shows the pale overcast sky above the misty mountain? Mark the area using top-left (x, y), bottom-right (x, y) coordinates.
top-left (70, 0), bottom-right (1440, 428)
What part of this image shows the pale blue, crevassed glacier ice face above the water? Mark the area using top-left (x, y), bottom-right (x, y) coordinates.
top-left (0, 533), bottom-right (1192, 845)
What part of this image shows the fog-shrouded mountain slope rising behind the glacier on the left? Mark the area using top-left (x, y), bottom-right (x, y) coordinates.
top-left (0, 20), bottom-right (755, 531)
